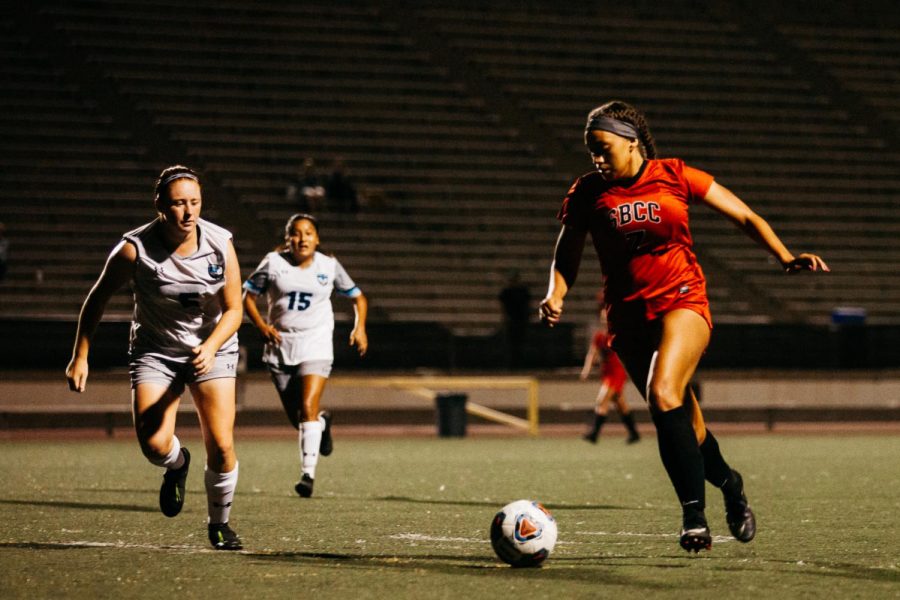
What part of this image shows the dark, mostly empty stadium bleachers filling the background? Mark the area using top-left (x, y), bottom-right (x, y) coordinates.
top-left (0, 0), bottom-right (900, 356)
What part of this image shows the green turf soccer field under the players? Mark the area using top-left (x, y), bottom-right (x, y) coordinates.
top-left (0, 429), bottom-right (900, 599)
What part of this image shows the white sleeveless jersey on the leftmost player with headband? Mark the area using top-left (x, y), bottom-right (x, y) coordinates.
top-left (122, 219), bottom-right (238, 362)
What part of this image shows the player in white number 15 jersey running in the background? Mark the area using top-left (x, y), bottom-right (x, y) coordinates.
top-left (244, 214), bottom-right (369, 498)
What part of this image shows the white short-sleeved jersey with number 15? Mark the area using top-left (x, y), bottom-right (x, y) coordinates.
top-left (244, 252), bottom-right (362, 365)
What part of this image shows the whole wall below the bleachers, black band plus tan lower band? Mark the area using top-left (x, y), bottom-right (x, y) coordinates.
top-left (0, 320), bottom-right (900, 433)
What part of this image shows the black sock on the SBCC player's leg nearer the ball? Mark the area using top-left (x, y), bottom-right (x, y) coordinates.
top-left (653, 406), bottom-right (706, 516)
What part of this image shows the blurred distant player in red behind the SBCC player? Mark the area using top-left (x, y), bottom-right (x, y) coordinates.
top-left (581, 292), bottom-right (641, 444)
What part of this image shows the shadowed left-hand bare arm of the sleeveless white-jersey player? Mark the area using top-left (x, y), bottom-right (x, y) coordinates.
top-left (66, 241), bottom-right (137, 392)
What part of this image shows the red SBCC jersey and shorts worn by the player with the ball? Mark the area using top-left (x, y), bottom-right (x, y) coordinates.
top-left (558, 159), bottom-right (713, 335)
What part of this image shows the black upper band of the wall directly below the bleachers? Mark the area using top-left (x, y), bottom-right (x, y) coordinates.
top-left (0, 319), bottom-right (900, 371)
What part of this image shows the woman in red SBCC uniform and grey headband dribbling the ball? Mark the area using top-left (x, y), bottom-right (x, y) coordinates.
top-left (540, 101), bottom-right (828, 552)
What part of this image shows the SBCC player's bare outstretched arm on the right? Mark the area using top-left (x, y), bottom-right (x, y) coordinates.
top-left (703, 182), bottom-right (831, 273)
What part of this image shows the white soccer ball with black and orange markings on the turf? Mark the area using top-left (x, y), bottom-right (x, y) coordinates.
top-left (491, 500), bottom-right (556, 567)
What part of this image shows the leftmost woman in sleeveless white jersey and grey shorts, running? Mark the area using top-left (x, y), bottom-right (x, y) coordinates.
top-left (66, 166), bottom-right (243, 550)
